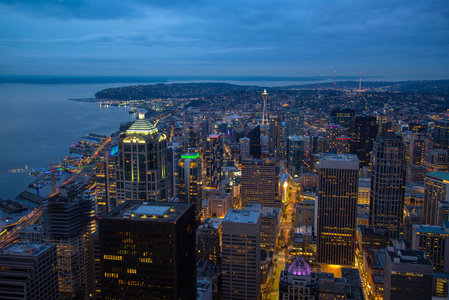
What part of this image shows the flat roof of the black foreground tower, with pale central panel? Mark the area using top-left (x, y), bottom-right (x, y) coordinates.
top-left (103, 200), bottom-right (193, 223)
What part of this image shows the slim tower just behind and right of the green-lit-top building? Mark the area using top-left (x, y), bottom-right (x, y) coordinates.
top-left (203, 133), bottom-right (224, 188)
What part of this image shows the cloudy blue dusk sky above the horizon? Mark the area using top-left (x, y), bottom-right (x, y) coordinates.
top-left (0, 0), bottom-right (449, 78)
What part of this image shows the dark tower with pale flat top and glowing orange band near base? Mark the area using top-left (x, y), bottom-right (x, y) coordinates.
top-left (317, 154), bottom-right (359, 265)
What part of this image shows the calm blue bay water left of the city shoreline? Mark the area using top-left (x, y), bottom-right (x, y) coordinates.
top-left (0, 83), bottom-right (141, 199)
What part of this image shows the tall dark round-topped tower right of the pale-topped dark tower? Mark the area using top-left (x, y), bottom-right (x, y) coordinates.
top-left (369, 132), bottom-right (405, 237)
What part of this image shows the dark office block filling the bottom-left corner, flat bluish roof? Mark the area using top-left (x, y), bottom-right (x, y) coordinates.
top-left (0, 243), bottom-right (60, 300)
